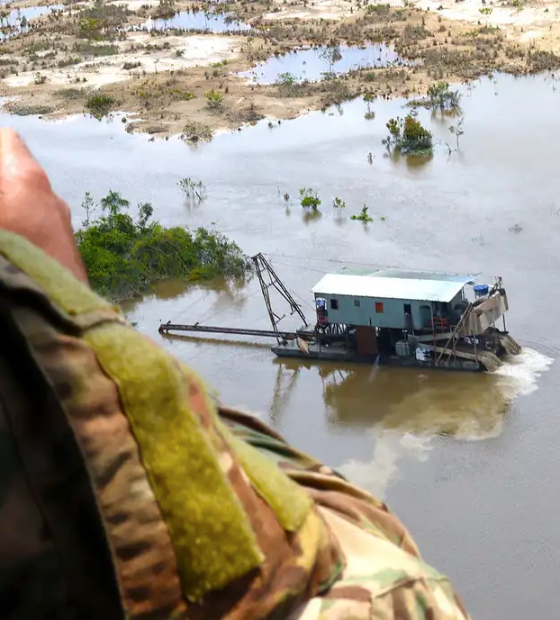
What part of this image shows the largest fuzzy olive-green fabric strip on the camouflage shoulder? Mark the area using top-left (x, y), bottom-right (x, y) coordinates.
top-left (84, 324), bottom-right (264, 600)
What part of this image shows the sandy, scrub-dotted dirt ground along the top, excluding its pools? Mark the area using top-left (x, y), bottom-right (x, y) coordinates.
top-left (0, 0), bottom-right (560, 141)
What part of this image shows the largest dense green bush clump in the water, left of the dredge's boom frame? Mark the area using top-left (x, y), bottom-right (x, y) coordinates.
top-left (76, 191), bottom-right (250, 303)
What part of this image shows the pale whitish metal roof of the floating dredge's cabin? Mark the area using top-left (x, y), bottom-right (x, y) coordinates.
top-left (312, 273), bottom-right (472, 303)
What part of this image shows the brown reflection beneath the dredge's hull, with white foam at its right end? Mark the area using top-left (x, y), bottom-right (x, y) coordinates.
top-left (276, 349), bottom-right (552, 440)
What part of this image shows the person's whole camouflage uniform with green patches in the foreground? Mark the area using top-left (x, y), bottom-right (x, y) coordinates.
top-left (0, 231), bottom-right (468, 620)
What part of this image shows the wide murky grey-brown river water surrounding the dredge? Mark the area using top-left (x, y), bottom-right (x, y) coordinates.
top-left (9, 71), bottom-right (560, 620)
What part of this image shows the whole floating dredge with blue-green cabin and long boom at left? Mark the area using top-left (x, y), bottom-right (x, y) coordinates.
top-left (159, 254), bottom-right (521, 371)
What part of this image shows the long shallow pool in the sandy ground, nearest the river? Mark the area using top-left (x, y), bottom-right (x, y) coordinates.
top-left (238, 44), bottom-right (405, 84)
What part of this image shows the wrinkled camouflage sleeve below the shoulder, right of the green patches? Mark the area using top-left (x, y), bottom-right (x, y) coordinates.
top-left (219, 406), bottom-right (469, 620)
